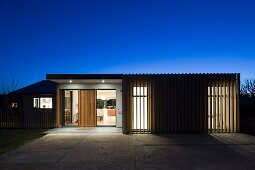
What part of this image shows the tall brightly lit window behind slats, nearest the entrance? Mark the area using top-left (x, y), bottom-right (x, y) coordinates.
top-left (132, 87), bottom-right (148, 130)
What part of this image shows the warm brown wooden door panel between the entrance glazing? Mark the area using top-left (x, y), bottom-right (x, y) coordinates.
top-left (78, 90), bottom-right (96, 127)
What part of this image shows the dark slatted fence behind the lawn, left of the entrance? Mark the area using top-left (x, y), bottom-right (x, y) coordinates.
top-left (0, 110), bottom-right (56, 128)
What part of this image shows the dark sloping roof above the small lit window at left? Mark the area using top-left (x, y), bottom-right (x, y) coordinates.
top-left (10, 80), bottom-right (57, 94)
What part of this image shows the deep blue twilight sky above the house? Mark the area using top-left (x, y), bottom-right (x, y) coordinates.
top-left (0, 0), bottom-right (255, 87)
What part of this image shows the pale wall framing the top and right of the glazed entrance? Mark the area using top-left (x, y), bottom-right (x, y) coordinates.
top-left (59, 83), bottom-right (122, 127)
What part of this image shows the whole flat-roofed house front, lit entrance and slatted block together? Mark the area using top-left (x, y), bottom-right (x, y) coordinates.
top-left (46, 73), bottom-right (240, 133)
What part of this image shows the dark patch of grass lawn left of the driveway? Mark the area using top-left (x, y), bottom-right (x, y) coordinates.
top-left (0, 129), bottom-right (46, 154)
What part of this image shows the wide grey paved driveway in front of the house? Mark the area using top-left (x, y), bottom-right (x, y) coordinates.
top-left (0, 133), bottom-right (255, 170)
